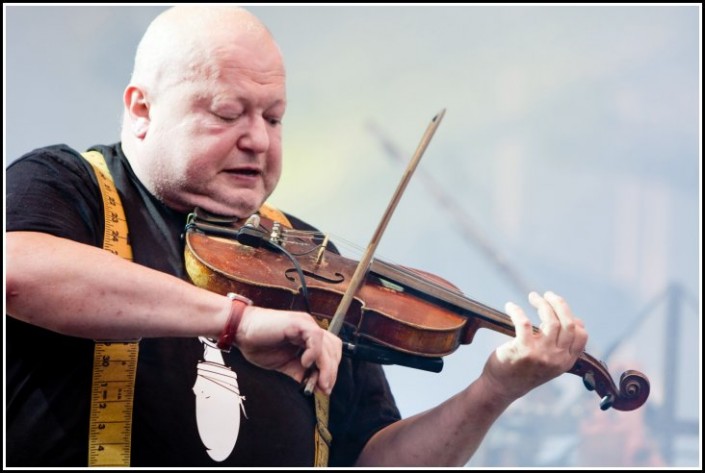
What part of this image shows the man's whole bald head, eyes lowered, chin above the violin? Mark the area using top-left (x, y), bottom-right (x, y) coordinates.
top-left (121, 5), bottom-right (286, 217)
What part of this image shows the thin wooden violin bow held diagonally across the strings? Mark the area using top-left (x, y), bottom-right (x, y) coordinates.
top-left (304, 108), bottom-right (446, 395)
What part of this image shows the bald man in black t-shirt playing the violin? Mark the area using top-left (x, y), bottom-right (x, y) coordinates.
top-left (6, 6), bottom-right (587, 466)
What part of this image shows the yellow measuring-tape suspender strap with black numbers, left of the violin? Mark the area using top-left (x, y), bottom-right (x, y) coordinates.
top-left (82, 151), bottom-right (139, 466)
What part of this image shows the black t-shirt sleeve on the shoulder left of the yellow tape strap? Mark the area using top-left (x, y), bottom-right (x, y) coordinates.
top-left (5, 145), bottom-right (103, 246)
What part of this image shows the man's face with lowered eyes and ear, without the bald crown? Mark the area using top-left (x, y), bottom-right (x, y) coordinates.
top-left (142, 38), bottom-right (286, 217)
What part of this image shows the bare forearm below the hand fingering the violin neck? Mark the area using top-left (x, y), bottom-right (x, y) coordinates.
top-left (356, 377), bottom-right (511, 467)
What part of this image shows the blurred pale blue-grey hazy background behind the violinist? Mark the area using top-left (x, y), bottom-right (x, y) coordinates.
top-left (3, 4), bottom-right (702, 467)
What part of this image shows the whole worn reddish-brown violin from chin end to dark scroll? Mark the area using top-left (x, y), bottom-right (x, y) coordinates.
top-left (184, 209), bottom-right (650, 411)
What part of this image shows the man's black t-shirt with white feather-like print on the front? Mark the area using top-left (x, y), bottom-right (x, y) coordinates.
top-left (5, 144), bottom-right (400, 467)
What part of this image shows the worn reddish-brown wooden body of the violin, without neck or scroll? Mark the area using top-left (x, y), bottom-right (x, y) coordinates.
top-left (185, 212), bottom-right (468, 357)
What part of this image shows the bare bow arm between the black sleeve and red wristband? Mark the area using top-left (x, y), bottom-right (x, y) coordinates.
top-left (6, 232), bottom-right (229, 339)
